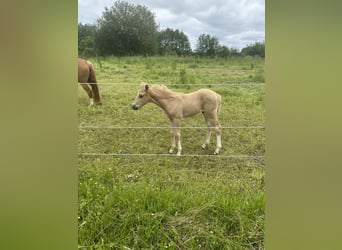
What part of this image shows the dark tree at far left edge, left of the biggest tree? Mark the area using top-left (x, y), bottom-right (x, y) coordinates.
top-left (78, 23), bottom-right (95, 57)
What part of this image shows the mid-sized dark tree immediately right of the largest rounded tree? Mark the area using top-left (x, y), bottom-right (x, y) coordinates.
top-left (158, 28), bottom-right (191, 56)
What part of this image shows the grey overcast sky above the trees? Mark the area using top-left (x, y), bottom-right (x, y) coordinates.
top-left (78, 0), bottom-right (265, 50)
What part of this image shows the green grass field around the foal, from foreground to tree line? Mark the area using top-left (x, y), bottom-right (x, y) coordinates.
top-left (78, 57), bottom-right (265, 249)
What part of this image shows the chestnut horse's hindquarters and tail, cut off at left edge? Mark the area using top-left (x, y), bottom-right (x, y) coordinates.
top-left (78, 58), bottom-right (101, 106)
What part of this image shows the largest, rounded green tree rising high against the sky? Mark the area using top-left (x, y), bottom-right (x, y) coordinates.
top-left (95, 1), bottom-right (158, 56)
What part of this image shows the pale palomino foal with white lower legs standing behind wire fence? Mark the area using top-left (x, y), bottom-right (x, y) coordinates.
top-left (132, 83), bottom-right (221, 156)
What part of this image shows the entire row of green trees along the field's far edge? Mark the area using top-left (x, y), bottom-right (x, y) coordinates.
top-left (78, 1), bottom-right (265, 58)
